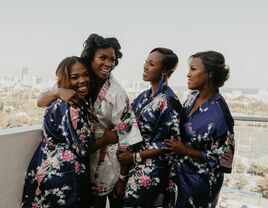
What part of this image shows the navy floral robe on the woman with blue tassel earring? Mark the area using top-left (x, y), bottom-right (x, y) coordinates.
top-left (124, 84), bottom-right (181, 207)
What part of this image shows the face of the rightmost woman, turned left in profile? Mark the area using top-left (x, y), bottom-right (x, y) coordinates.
top-left (187, 58), bottom-right (208, 90)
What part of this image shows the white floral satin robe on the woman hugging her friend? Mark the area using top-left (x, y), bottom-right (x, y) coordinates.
top-left (90, 75), bottom-right (142, 196)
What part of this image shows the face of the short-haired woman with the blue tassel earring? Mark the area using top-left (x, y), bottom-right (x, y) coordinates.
top-left (143, 51), bottom-right (163, 83)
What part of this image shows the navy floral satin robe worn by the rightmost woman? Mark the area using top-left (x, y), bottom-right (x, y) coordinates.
top-left (176, 91), bottom-right (234, 208)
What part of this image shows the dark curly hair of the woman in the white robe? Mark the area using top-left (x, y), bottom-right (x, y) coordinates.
top-left (81, 33), bottom-right (123, 66)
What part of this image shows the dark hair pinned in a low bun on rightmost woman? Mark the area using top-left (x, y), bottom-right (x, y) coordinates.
top-left (189, 51), bottom-right (230, 88)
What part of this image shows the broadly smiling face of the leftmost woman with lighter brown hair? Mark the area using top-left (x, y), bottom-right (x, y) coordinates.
top-left (69, 62), bottom-right (90, 96)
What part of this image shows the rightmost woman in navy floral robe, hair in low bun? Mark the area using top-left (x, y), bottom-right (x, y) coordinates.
top-left (165, 51), bottom-right (234, 208)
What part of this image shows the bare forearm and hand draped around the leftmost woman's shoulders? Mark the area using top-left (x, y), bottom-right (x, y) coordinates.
top-left (37, 88), bottom-right (85, 107)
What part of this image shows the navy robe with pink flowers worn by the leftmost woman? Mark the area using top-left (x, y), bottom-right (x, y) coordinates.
top-left (22, 99), bottom-right (94, 208)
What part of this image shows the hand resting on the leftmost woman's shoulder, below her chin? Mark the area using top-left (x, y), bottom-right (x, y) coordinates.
top-left (57, 88), bottom-right (86, 106)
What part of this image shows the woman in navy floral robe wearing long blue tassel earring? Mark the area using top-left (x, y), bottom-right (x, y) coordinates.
top-left (119, 48), bottom-right (181, 207)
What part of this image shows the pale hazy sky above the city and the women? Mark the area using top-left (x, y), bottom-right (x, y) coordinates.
top-left (0, 0), bottom-right (268, 89)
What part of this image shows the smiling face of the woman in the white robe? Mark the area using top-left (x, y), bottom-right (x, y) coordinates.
top-left (91, 48), bottom-right (116, 80)
